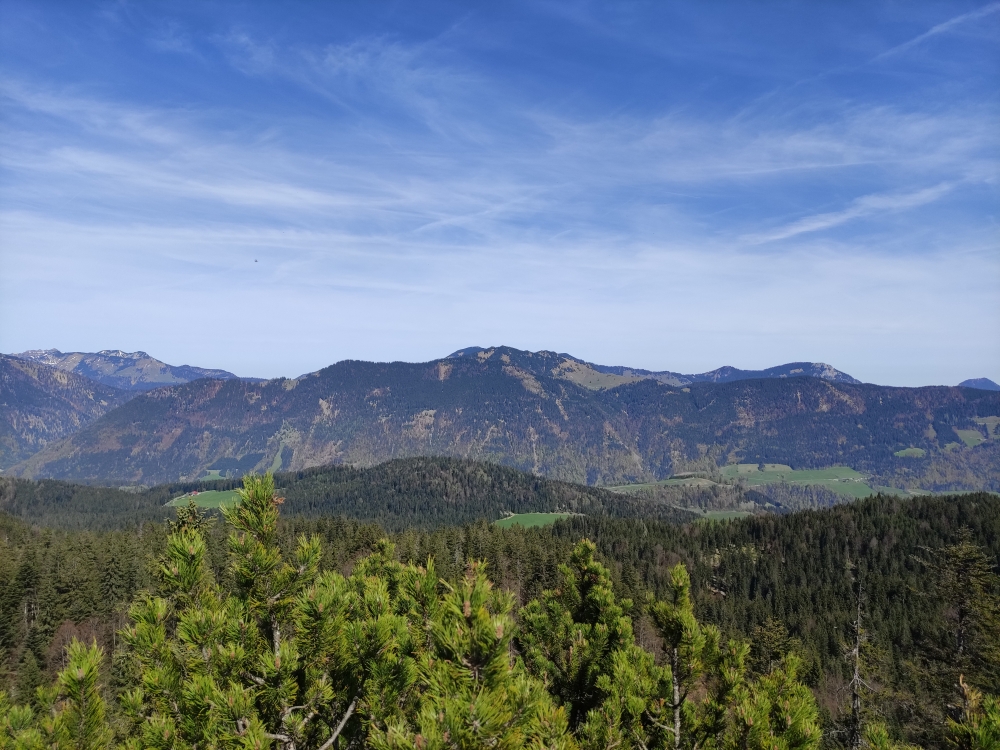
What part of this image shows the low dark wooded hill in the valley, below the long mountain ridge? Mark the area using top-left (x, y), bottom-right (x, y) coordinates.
top-left (0, 458), bottom-right (694, 531)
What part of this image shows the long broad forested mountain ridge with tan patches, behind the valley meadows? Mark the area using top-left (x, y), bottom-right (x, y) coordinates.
top-left (9, 349), bottom-right (1000, 490)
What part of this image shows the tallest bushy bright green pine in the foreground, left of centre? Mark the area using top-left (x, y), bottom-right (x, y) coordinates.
top-left (123, 475), bottom-right (430, 750)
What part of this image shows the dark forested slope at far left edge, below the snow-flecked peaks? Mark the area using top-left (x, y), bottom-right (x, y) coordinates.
top-left (0, 354), bottom-right (131, 470)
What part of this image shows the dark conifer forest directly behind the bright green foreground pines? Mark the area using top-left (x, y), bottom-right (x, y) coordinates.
top-left (0, 494), bottom-right (1000, 748)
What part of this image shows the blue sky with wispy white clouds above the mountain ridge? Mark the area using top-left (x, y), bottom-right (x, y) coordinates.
top-left (0, 0), bottom-right (1000, 385)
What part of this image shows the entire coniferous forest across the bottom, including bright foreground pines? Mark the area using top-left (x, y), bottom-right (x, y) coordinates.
top-left (0, 475), bottom-right (1000, 748)
